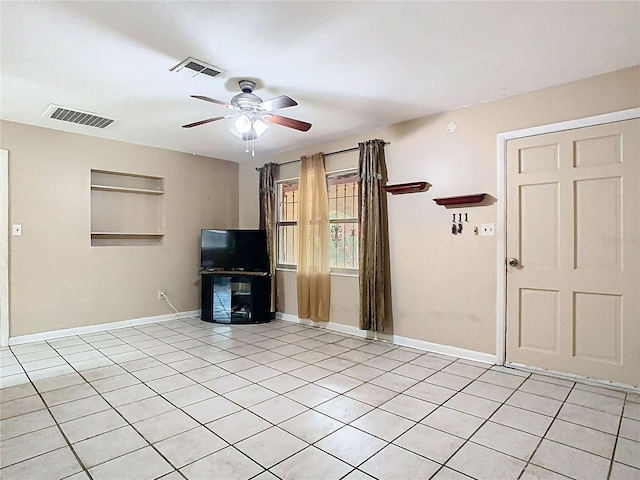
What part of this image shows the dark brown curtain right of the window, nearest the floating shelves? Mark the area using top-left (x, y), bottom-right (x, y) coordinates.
top-left (358, 140), bottom-right (391, 332)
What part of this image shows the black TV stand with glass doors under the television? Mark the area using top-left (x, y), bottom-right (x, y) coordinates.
top-left (200, 270), bottom-right (271, 323)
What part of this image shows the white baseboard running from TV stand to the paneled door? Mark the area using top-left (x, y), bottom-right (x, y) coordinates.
top-left (276, 312), bottom-right (496, 365)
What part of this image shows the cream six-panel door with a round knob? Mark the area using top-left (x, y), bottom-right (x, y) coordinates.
top-left (506, 119), bottom-right (640, 387)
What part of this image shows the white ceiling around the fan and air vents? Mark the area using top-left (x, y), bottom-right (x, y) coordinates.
top-left (0, 1), bottom-right (640, 161)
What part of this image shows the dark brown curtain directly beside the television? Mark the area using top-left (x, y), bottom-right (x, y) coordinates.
top-left (260, 163), bottom-right (278, 314)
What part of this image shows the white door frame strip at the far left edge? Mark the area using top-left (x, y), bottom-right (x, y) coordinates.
top-left (0, 150), bottom-right (9, 347)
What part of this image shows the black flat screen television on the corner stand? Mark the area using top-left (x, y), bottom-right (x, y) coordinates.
top-left (200, 230), bottom-right (269, 272)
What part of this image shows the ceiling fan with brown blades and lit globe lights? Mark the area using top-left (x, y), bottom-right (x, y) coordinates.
top-left (182, 80), bottom-right (311, 141)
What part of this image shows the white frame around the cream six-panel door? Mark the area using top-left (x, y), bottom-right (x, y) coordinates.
top-left (496, 108), bottom-right (640, 365)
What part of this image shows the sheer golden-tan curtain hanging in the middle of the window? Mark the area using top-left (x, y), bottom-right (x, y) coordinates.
top-left (297, 153), bottom-right (331, 322)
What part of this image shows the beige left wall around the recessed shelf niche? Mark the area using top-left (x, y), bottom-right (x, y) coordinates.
top-left (0, 122), bottom-right (238, 337)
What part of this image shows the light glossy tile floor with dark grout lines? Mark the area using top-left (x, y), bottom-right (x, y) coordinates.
top-left (0, 318), bottom-right (640, 480)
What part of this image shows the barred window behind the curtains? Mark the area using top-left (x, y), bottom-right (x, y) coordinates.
top-left (277, 170), bottom-right (358, 271)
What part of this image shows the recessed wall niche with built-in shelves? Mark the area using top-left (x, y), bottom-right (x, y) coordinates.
top-left (91, 170), bottom-right (164, 246)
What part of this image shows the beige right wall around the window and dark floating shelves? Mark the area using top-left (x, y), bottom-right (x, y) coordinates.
top-left (240, 67), bottom-right (640, 353)
